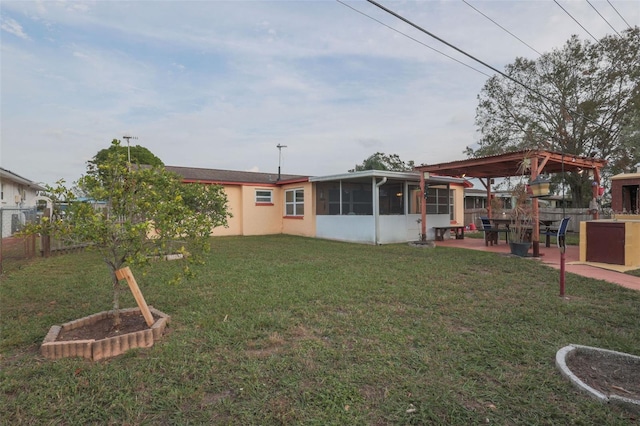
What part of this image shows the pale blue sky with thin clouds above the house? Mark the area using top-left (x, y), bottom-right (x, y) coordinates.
top-left (0, 0), bottom-right (640, 184)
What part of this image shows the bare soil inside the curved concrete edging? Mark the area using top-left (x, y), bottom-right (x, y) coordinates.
top-left (566, 350), bottom-right (640, 400)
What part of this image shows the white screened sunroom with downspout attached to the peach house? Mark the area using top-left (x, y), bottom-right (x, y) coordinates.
top-left (309, 170), bottom-right (464, 244)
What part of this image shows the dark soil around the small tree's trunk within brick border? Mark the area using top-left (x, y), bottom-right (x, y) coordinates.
top-left (56, 312), bottom-right (159, 342)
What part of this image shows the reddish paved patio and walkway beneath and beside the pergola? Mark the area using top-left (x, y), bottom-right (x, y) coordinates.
top-left (435, 233), bottom-right (640, 291)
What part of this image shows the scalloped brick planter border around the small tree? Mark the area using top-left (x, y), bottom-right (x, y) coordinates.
top-left (40, 306), bottom-right (171, 361)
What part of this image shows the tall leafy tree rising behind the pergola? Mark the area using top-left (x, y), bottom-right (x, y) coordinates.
top-left (466, 27), bottom-right (640, 206)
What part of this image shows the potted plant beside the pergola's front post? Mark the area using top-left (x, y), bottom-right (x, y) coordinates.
top-left (509, 183), bottom-right (533, 257)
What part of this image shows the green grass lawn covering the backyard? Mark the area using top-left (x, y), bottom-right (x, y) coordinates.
top-left (0, 235), bottom-right (640, 425)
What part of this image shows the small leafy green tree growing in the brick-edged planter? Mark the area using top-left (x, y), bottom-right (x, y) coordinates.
top-left (27, 140), bottom-right (230, 327)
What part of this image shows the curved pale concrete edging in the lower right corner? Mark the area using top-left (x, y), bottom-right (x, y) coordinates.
top-left (556, 344), bottom-right (640, 413)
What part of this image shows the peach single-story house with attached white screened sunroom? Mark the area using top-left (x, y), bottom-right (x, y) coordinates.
top-left (166, 166), bottom-right (468, 244)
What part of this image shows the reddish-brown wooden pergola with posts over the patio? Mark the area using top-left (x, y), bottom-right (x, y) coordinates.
top-left (415, 150), bottom-right (607, 257)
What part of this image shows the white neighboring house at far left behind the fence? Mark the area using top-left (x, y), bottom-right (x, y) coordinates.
top-left (0, 167), bottom-right (45, 238)
